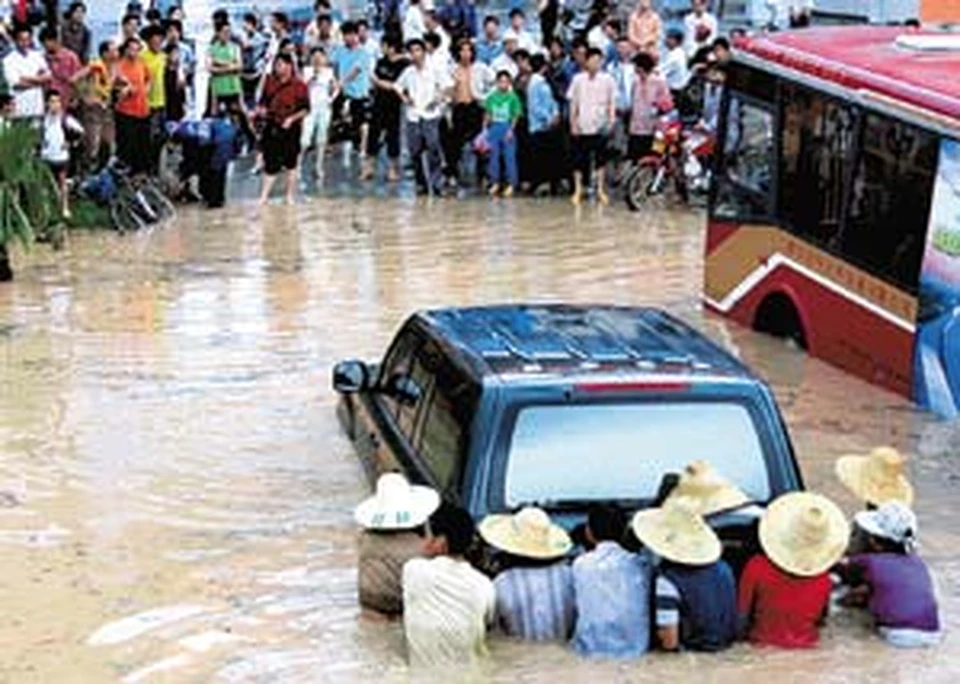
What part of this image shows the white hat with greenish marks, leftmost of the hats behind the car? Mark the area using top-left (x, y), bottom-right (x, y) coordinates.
top-left (353, 473), bottom-right (440, 530)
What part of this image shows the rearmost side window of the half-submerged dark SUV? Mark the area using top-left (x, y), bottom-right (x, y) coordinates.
top-left (418, 360), bottom-right (479, 493)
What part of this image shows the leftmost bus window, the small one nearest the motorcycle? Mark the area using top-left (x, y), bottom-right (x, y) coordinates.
top-left (713, 97), bottom-right (774, 220)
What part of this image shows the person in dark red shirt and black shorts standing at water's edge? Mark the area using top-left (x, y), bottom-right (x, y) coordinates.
top-left (258, 53), bottom-right (310, 204)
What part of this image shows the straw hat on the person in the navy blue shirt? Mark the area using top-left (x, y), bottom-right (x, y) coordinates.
top-left (631, 497), bottom-right (722, 565)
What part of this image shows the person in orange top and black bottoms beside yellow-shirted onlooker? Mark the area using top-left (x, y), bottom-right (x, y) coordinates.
top-left (113, 38), bottom-right (150, 174)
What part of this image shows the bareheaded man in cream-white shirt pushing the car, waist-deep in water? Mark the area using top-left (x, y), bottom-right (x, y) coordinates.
top-left (403, 500), bottom-right (496, 666)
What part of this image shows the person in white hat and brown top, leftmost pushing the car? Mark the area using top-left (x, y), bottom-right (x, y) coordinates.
top-left (353, 473), bottom-right (440, 615)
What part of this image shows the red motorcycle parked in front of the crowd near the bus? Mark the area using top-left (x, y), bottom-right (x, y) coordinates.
top-left (624, 113), bottom-right (714, 211)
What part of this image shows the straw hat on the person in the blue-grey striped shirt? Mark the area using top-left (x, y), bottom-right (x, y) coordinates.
top-left (478, 506), bottom-right (573, 559)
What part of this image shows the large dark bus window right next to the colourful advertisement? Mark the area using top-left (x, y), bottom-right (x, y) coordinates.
top-left (840, 112), bottom-right (939, 292)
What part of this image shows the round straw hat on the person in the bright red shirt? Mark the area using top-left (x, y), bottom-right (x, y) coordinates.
top-left (760, 492), bottom-right (850, 577)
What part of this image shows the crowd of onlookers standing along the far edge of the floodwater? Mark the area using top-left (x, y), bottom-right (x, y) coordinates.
top-left (0, 0), bottom-right (808, 211)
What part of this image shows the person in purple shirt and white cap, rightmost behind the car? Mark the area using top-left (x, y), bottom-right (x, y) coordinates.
top-left (841, 501), bottom-right (941, 648)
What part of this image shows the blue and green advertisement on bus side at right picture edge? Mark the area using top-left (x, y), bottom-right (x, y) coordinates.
top-left (914, 138), bottom-right (960, 418)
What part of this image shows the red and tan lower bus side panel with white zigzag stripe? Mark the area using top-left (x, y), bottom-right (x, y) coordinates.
top-left (704, 220), bottom-right (916, 397)
